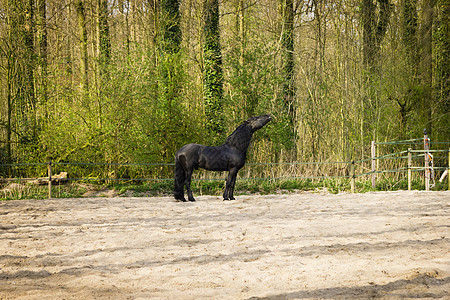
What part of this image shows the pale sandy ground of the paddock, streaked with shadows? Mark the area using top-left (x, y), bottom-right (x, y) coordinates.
top-left (0, 191), bottom-right (450, 299)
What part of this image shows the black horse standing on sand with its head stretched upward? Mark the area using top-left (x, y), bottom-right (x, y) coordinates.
top-left (174, 115), bottom-right (271, 202)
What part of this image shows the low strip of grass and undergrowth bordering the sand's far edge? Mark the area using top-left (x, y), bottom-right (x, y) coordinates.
top-left (0, 177), bottom-right (448, 200)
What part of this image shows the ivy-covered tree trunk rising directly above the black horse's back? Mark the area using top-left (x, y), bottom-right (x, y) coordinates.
top-left (203, 0), bottom-right (225, 137)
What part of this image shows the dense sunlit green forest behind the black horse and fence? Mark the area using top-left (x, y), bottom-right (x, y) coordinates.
top-left (0, 0), bottom-right (450, 180)
